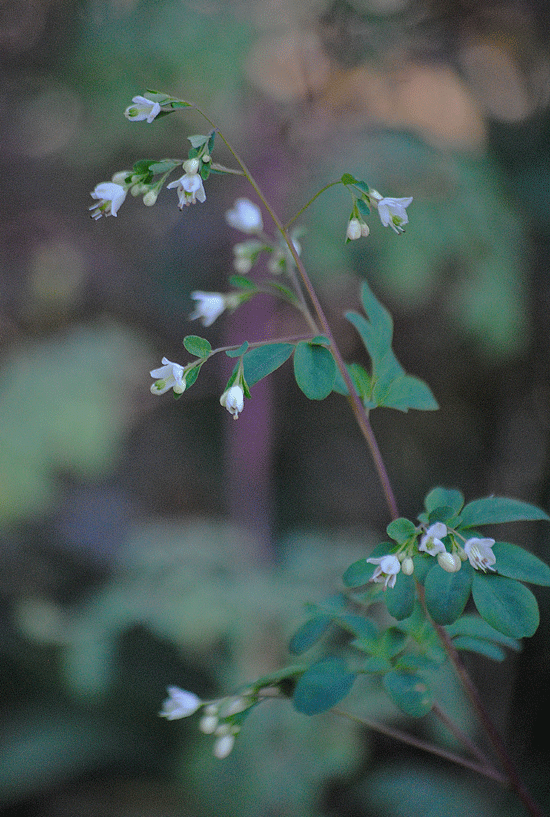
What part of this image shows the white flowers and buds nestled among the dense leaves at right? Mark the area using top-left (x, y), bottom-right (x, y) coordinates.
top-left (367, 522), bottom-right (496, 589)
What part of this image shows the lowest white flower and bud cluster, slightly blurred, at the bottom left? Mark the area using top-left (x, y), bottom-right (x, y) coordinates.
top-left (159, 686), bottom-right (258, 760)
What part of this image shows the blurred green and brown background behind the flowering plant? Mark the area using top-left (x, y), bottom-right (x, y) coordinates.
top-left (0, 0), bottom-right (550, 817)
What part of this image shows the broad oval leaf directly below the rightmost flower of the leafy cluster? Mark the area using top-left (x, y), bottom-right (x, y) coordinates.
top-left (472, 570), bottom-right (539, 638)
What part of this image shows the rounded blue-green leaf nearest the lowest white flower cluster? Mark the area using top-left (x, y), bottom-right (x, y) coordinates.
top-left (293, 658), bottom-right (356, 715)
